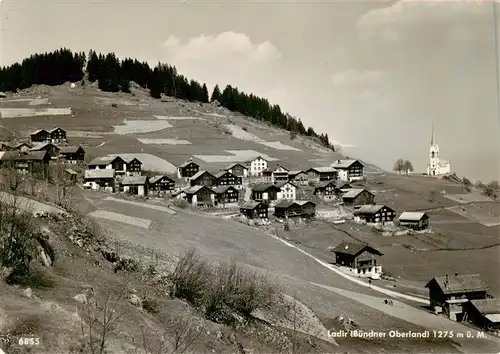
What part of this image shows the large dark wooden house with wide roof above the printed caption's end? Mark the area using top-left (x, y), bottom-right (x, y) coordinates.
top-left (425, 273), bottom-right (489, 321)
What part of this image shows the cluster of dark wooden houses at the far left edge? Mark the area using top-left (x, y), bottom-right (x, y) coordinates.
top-left (0, 127), bottom-right (85, 175)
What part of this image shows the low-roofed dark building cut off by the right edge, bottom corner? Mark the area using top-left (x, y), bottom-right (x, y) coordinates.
top-left (463, 299), bottom-right (500, 331)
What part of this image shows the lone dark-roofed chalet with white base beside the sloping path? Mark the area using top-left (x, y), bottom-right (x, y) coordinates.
top-left (332, 241), bottom-right (383, 279)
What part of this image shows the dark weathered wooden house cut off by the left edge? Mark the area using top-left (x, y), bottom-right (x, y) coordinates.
top-left (0, 151), bottom-right (51, 176)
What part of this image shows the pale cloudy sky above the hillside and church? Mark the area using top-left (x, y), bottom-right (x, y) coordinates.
top-left (0, 0), bottom-right (500, 181)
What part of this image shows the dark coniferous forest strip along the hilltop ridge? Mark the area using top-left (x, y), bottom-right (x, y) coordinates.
top-left (0, 48), bottom-right (334, 150)
